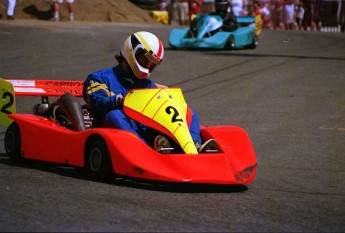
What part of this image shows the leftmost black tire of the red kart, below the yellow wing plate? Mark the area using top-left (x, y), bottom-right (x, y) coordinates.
top-left (5, 122), bottom-right (23, 162)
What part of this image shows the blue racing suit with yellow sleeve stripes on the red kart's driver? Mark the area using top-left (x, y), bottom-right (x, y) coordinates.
top-left (83, 65), bottom-right (201, 145)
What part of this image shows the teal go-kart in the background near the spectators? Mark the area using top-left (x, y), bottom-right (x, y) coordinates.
top-left (169, 14), bottom-right (258, 50)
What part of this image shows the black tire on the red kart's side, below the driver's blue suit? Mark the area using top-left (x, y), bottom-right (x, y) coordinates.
top-left (85, 138), bottom-right (114, 180)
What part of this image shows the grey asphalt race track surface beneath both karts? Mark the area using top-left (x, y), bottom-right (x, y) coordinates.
top-left (0, 20), bottom-right (345, 232)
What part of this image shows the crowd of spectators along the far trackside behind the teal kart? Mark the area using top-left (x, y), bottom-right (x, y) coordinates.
top-left (160, 0), bottom-right (345, 32)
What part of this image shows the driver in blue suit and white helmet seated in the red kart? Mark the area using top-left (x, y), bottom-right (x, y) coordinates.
top-left (83, 31), bottom-right (218, 153)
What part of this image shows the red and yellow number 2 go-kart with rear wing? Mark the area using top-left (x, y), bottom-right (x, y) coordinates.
top-left (0, 79), bottom-right (257, 184)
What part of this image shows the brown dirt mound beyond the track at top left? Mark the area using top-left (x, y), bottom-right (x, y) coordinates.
top-left (0, 0), bottom-right (157, 24)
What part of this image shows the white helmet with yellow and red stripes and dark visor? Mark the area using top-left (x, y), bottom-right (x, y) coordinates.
top-left (121, 31), bottom-right (164, 79)
